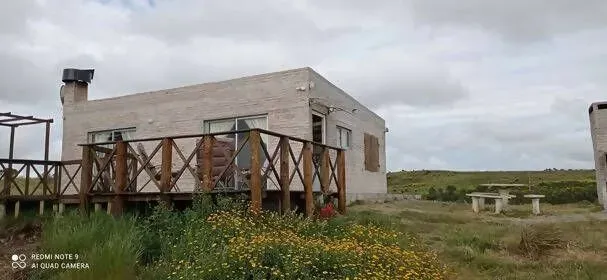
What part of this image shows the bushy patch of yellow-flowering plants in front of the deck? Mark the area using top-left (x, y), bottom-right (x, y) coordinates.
top-left (146, 196), bottom-right (446, 279)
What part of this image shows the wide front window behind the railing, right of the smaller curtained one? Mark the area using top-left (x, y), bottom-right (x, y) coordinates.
top-left (203, 115), bottom-right (268, 169)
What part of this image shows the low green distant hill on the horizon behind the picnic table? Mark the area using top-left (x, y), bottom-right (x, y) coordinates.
top-left (388, 169), bottom-right (595, 193)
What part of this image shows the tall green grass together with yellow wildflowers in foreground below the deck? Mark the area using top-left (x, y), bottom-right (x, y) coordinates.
top-left (12, 197), bottom-right (450, 280)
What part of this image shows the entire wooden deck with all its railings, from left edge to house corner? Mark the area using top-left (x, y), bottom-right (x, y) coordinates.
top-left (0, 129), bottom-right (346, 216)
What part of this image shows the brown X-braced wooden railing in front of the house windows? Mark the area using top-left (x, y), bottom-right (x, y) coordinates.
top-left (79, 129), bottom-right (346, 215)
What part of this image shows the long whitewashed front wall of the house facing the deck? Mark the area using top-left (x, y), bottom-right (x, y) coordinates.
top-left (62, 68), bottom-right (311, 194)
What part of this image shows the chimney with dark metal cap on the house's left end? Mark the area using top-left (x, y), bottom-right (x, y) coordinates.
top-left (60, 68), bottom-right (95, 106)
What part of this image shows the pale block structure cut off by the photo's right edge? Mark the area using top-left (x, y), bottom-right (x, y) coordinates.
top-left (589, 102), bottom-right (607, 207)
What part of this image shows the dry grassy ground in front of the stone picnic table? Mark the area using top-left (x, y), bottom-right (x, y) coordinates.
top-left (348, 201), bottom-right (607, 279)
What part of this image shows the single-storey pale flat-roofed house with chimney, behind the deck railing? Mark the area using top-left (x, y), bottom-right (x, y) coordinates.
top-left (61, 67), bottom-right (387, 201)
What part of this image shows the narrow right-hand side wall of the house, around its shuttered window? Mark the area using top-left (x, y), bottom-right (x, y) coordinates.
top-left (310, 71), bottom-right (388, 200)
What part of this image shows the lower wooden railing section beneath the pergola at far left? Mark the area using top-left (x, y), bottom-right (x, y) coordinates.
top-left (0, 159), bottom-right (80, 200)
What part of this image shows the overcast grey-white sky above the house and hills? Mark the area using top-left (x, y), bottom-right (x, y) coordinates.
top-left (0, 0), bottom-right (607, 170)
